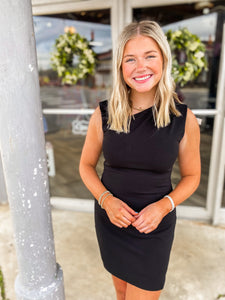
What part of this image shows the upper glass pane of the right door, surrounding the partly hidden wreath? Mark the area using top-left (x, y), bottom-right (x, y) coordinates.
top-left (134, 1), bottom-right (225, 109)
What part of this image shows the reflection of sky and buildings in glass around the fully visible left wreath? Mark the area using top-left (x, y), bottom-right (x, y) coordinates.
top-left (34, 11), bottom-right (112, 108)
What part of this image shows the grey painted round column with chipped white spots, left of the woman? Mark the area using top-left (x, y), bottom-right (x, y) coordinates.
top-left (0, 0), bottom-right (64, 300)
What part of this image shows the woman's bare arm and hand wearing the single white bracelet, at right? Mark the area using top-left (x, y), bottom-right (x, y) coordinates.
top-left (133, 109), bottom-right (201, 233)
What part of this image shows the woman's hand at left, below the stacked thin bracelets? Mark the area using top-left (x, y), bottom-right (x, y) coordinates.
top-left (103, 196), bottom-right (138, 228)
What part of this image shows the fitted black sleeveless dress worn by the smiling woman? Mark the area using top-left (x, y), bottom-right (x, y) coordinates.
top-left (95, 101), bottom-right (187, 291)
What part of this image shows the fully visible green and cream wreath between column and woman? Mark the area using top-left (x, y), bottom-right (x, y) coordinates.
top-left (51, 27), bottom-right (96, 85)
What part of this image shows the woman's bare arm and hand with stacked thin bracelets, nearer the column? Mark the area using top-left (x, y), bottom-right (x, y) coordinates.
top-left (79, 107), bottom-right (136, 227)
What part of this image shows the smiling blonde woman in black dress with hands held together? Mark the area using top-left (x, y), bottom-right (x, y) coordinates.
top-left (80, 21), bottom-right (200, 300)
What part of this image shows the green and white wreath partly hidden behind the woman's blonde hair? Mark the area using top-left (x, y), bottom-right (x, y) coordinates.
top-left (166, 28), bottom-right (207, 86)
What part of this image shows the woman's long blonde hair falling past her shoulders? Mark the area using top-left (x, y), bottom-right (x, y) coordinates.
top-left (108, 21), bottom-right (181, 133)
